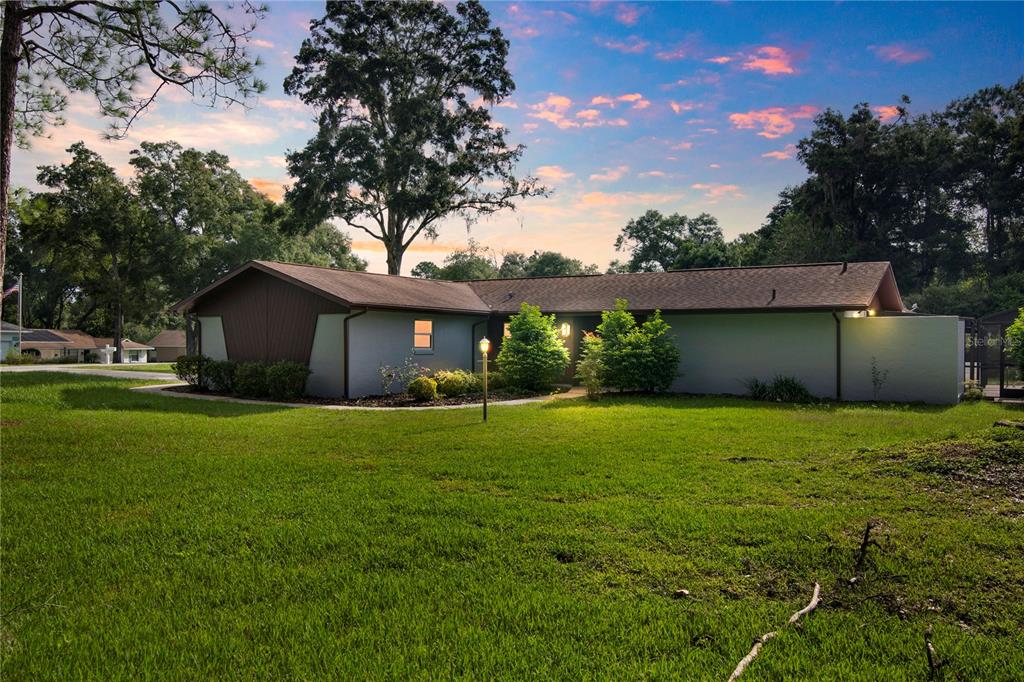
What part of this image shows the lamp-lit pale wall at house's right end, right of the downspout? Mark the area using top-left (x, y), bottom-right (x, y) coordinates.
top-left (843, 315), bottom-right (964, 404)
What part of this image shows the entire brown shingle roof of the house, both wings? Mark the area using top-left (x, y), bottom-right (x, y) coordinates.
top-left (174, 261), bottom-right (903, 313)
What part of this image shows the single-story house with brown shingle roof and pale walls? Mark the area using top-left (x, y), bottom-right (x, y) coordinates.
top-left (174, 261), bottom-right (964, 403)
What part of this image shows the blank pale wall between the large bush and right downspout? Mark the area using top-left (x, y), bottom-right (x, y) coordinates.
top-left (665, 312), bottom-right (836, 397)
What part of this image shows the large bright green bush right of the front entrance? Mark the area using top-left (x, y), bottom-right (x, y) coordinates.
top-left (597, 299), bottom-right (679, 391)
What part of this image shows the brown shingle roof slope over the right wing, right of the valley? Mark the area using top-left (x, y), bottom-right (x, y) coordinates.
top-left (470, 262), bottom-right (902, 312)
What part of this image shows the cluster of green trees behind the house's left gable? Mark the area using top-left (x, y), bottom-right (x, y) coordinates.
top-left (4, 142), bottom-right (367, 348)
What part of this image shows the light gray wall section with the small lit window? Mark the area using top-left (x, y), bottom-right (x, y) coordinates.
top-left (348, 310), bottom-right (485, 397)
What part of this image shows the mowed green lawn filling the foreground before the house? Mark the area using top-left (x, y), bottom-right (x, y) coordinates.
top-left (0, 373), bottom-right (1024, 680)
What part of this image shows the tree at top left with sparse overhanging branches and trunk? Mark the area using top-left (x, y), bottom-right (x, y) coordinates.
top-left (0, 0), bottom-right (265, 288)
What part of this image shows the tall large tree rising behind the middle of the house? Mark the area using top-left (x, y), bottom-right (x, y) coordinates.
top-left (285, 0), bottom-right (544, 274)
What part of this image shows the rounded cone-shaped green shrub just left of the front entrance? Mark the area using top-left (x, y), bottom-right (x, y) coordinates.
top-left (498, 303), bottom-right (569, 390)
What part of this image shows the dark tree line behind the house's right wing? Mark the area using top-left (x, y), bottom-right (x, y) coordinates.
top-left (414, 79), bottom-right (1024, 316)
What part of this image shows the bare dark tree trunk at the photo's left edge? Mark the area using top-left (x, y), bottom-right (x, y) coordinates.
top-left (0, 0), bottom-right (25, 282)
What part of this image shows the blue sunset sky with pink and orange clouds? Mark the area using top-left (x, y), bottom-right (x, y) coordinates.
top-left (12, 2), bottom-right (1024, 272)
